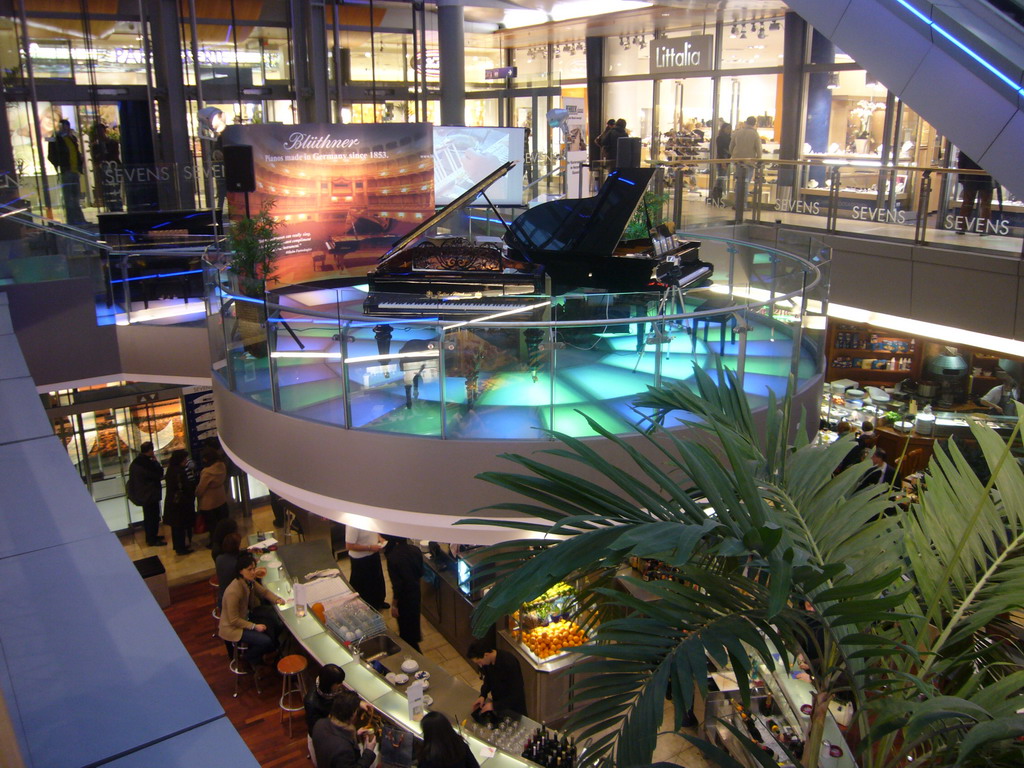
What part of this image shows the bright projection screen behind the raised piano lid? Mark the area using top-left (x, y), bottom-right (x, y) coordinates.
top-left (434, 126), bottom-right (525, 206)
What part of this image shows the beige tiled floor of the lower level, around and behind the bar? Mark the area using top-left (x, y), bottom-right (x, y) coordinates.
top-left (121, 506), bottom-right (708, 768)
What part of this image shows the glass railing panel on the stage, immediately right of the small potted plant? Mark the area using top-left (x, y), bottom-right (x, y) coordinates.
top-left (268, 305), bottom-right (349, 427)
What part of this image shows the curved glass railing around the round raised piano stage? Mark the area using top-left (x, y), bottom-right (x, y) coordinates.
top-left (205, 233), bottom-right (828, 439)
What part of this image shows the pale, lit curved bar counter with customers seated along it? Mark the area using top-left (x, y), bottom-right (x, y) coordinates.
top-left (263, 541), bottom-right (540, 768)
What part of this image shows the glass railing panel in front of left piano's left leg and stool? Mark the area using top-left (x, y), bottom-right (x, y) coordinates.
top-left (345, 317), bottom-right (442, 437)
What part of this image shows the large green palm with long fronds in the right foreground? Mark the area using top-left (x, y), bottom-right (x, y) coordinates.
top-left (464, 370), bottom-right (1024, 768)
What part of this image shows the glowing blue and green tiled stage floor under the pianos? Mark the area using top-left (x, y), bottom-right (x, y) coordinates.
top-left (231, 313), bottom-right (817, 439)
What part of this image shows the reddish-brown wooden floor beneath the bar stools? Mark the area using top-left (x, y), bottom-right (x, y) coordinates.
top-left (164, 581), bottom-right (312, 768)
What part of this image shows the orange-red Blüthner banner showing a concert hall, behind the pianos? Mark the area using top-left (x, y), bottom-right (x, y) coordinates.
top-left (224, 123), bottom-right (434, 285)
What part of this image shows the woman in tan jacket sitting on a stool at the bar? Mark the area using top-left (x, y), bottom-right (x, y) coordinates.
top-left (217, 552), bottom-right (285, 666)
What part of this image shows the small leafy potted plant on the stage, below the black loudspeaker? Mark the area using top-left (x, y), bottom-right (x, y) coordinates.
top-left (227, 198), bottom-right (281, 357)
